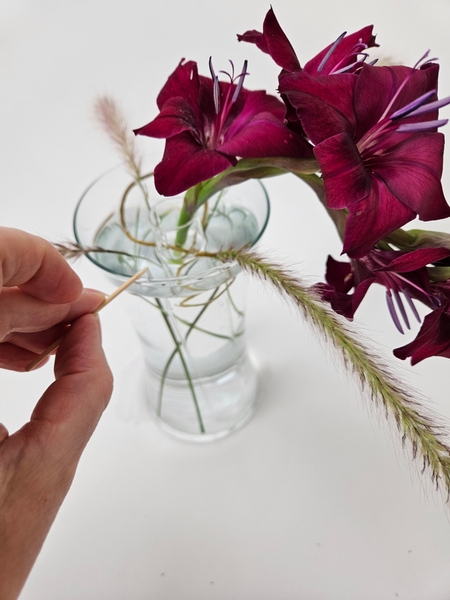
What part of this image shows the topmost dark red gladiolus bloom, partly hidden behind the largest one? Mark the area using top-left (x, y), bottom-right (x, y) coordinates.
top-left (237, 9), bottom-right (378, 76)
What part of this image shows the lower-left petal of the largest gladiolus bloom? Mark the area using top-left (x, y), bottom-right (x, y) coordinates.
top-left (314, 133), bottom-right (371, 209)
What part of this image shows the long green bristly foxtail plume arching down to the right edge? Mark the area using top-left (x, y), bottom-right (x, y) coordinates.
top-left (221, 250), bottom-right (450, 500)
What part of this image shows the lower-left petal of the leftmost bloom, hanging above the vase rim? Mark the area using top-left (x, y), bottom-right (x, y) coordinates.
top-left (155, 132), bottom-right (237, 196)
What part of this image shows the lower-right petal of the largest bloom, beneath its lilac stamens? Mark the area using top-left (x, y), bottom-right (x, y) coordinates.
top-left (376, 133), bottom-right (450, 221)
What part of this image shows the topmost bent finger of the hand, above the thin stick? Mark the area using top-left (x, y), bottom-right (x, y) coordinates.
top-left (0, 227), bottom-right (82, 304)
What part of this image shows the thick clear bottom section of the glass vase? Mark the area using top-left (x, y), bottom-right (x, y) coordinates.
top-left (146, 356), bottom-right (259, 443)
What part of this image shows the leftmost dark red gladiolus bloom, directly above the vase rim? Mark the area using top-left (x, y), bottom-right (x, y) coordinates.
top-left (135, 61), bottom-right (313, 196)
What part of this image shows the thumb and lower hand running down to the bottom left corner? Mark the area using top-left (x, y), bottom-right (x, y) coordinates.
top-left (0, 315), bottom-right (112, 598)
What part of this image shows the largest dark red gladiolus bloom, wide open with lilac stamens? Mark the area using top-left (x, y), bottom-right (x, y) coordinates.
top-left (280, 63), bottom-right (450, 258)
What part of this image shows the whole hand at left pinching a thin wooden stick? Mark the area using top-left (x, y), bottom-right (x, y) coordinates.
top-left (0, 228), bottom-right (112, 600)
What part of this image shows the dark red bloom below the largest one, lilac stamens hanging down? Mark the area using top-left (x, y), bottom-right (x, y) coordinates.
top-left (315, 248), bottom-right (450, 333)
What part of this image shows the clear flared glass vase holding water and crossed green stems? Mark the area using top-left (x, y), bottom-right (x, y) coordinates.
top-left (74, 164), bottom-right (269, 441)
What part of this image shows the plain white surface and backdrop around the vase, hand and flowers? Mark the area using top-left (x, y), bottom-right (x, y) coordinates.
top-left (0, 0), bottom-right (450, 600)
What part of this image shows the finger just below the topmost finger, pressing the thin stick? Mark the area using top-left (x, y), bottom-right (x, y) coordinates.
top-left (0, 288), bottom-right (105, 341)
